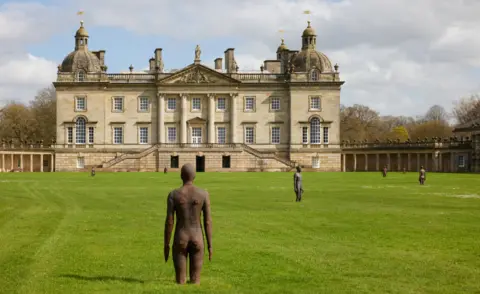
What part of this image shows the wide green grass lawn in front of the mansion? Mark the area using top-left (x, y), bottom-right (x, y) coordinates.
top-left (0, 173), bottom-right (480, 294)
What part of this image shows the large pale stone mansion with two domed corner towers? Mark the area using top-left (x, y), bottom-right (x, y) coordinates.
top-left (50, 22), bottom-right (344, 171)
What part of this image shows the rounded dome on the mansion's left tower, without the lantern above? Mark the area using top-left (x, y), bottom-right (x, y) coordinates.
top-left (62, 49), bottom-right (101, 72)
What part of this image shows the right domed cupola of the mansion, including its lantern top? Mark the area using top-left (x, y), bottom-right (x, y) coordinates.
top-left (291, 22), bottom-right (333, 73)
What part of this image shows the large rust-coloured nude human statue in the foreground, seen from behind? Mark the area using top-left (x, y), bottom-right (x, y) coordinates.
top-left (164, 164), bottom-right (213, 284)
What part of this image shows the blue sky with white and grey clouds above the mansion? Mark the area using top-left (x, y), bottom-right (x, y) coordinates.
top-left (0, 0), bottom-right (480, 115)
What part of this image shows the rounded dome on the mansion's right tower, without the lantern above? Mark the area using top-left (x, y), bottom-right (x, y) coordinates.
top-left (292, 50), bottom-right (333, 72)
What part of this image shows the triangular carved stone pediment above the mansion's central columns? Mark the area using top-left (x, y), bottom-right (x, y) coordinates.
top-left (160, 64), bottom-right (240, 84)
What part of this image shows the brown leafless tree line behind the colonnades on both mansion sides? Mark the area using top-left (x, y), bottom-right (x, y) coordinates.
top-left (0, 87), bottom-right (480, 143)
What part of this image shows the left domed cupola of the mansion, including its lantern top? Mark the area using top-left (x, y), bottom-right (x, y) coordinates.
top-left (59, 21), bottom-right (102, 74)
